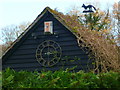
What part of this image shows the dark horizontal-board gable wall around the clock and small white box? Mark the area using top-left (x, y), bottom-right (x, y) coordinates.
top-left (3, 11), bottom-right (92, 71)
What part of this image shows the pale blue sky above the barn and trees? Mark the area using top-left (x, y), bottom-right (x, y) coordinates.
top-left (0, 0), bottom-right (119, 43)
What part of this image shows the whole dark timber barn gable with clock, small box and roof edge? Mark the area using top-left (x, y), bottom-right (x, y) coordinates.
top-left (2, 7), bottom-right (94, 71)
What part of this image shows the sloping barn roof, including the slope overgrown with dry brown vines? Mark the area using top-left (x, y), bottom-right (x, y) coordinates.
top-left (2, 7), bottom-right (119, 71)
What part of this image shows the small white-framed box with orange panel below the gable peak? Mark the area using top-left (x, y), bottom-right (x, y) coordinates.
top-left (44, 21), bottom-right (53, 34)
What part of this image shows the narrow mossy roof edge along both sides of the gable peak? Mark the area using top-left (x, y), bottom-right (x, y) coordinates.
top-left (2, 6), bottom-right (76, 58)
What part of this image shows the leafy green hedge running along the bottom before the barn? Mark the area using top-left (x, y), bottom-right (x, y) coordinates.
top-left (2, 68), bottom-right (120, 90)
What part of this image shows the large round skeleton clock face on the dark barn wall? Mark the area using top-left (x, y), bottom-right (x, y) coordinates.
top-left (36, 40), bottom-right (62, 67)
